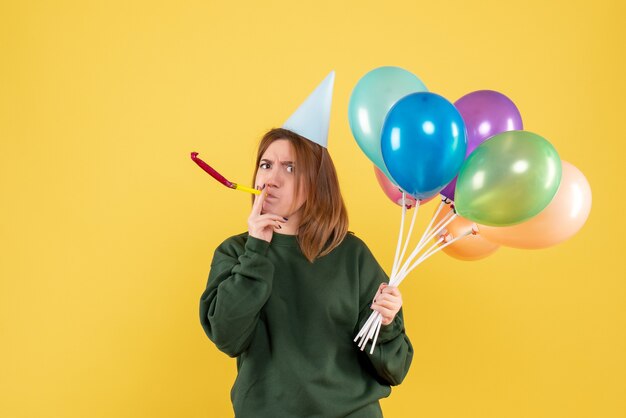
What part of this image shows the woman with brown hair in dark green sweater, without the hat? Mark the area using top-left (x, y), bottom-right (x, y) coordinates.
top-left (200, 129), bottom-right (413, 418)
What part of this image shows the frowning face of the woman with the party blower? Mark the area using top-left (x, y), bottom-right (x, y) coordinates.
top-left (255, 139), bottom-right (306, 220)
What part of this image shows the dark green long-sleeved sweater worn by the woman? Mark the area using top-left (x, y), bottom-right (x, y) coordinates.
top-left (200, 233), bottom-right (413, 418)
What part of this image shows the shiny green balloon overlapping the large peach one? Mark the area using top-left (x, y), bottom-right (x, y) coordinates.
top-left (454, 131), bottom-right (561, 226)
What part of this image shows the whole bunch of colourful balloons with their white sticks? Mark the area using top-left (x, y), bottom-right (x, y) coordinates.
top-left (348, 67), bottom-right (591, 353)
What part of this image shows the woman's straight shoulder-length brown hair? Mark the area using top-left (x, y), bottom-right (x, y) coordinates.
top-left (252, 128), bottom-right (348, 262)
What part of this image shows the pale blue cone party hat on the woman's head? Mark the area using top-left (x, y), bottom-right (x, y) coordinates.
top-left (283, 70), bottom-right (335, 148)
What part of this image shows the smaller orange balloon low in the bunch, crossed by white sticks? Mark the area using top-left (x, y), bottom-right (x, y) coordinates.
top-left (433, 204), bottom-right (500, 261)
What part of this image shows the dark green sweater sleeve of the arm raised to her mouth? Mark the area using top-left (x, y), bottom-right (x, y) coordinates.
top-left (200, 236), bottom-right (274, 357)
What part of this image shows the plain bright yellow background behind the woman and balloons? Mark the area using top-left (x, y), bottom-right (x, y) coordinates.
top-left (0, 0), bottom-right (626, 418)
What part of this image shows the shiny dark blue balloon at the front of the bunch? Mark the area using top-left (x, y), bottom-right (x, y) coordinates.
top-left (381, 92), bottom-right (467, 199)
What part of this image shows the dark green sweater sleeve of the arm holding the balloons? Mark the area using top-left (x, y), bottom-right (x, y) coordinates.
top-left (355, 240), bottom-right (413, 386)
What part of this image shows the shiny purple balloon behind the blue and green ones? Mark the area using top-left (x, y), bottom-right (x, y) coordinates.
top-left (440, 90), bottom-right (524, 200)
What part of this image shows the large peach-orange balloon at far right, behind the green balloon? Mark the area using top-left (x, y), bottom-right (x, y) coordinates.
top-left (478, 160), bottom-right (591, 249)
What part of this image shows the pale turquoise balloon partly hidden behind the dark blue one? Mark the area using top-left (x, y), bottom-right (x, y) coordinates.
top-left (348, 67), bottom-right (428, 181)
